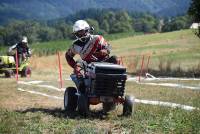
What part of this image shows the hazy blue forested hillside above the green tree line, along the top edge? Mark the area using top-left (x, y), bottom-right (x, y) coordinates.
top-left (0, 0), bottom-right (191, 24)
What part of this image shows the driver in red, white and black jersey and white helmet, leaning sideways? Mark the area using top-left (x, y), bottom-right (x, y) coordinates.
top-left (65, 20), bottom-right (117, 76)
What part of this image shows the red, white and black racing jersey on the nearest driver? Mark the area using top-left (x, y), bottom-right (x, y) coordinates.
top-left (65, 35), bottom-right (110, 68)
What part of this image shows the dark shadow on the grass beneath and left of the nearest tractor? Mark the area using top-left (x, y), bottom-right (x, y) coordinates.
top-left (16, 108), bottom-right (107, 119)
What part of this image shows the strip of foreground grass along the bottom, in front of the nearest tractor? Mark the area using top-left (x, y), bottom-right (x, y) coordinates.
top-left (0, 105), bottom-right (200, 134)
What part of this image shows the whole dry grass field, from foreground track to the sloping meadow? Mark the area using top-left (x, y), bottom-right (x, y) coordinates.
top-left (0, 30), bottom-right (200, 134)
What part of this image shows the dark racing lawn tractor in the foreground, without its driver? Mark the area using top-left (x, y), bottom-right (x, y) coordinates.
top-left (64, 61), bottom-right (134, 116)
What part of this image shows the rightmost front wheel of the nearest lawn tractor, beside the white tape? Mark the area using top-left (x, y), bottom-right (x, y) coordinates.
top-left (123, 96), bottom-right (134, 116)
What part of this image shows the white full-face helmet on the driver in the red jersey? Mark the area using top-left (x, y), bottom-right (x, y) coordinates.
top-left (73, 20), bottom-right (90, 42)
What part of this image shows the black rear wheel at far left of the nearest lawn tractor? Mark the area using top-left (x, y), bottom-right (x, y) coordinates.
top-left (64, 87), bottom-right (78, 111)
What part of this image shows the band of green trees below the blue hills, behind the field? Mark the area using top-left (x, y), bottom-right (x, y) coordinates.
top-left (0, 9), bottom-right (191, 46)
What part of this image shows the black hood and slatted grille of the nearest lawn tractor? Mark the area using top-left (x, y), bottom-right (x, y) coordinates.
top-left (87, 62), bottom-right (127, 97)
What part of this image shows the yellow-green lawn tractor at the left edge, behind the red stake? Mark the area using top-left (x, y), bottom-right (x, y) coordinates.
top-left (0, 56), bottom-right (31, 78)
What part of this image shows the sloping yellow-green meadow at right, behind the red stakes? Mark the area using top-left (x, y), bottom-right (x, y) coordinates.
top-left (110, 30), bottom-right (200, 72)
